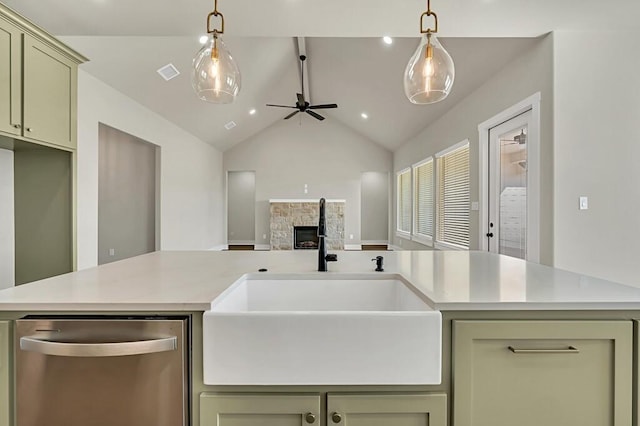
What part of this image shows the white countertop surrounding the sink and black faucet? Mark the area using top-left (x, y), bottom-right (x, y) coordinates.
top-left (0, 250), bottom-right (640, 312)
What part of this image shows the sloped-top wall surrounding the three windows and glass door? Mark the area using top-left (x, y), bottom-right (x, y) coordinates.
top-left (392, 35), bottom-right (553, 264)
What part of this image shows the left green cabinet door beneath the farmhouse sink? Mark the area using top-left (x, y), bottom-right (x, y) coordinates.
top-left (200, 393), bottom-right (320, 426)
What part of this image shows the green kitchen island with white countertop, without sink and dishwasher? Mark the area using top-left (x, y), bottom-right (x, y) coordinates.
top-left (0, 251), bottom-right (640, 426)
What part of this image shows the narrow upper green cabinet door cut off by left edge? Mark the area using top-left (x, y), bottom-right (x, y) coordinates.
top-left (0, 15), bottom-right (22, 136)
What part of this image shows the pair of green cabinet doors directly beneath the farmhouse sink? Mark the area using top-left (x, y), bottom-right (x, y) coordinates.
top-left (200, 393), bottom-right (447, 426)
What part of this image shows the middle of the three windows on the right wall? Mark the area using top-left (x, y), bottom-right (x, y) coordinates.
top-left (413, 157), bottom-right (434, 244)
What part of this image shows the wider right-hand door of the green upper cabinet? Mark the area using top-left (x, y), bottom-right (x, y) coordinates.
top-left (23, 34), bottom-right (78, 149)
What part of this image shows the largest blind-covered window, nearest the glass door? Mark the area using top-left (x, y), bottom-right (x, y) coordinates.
top-left (436, 141), bottom-right (470, 249)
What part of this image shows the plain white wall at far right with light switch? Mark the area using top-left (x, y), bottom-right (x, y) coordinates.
top-left (554, 31), bottom-right (640, 286)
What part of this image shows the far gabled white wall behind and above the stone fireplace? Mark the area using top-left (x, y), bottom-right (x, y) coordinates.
top-left (224, 116), bottom-right (392, 245)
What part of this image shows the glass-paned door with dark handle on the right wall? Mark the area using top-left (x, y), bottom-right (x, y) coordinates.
top-left (486, 110), bottom-right (535, 260)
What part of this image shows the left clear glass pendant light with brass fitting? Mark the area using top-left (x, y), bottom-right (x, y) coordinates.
top-left (191, 0), bottom-right (240, 104)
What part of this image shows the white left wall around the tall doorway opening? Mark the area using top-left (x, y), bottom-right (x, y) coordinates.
top-left (77, 70), bottom-right (224, 269)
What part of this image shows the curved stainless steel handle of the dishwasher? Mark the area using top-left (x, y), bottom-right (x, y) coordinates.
top-left (20, 336), bottom-right (178, 357)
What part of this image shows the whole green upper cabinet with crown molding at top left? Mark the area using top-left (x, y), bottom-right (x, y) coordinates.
top-left (0, 4), bottom-right (86, 149)
